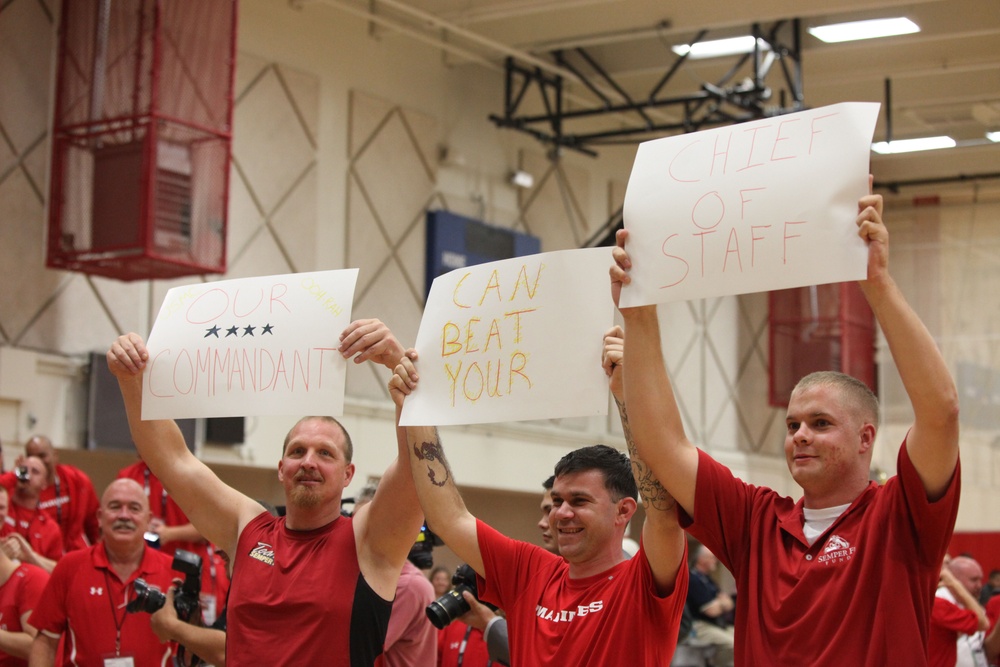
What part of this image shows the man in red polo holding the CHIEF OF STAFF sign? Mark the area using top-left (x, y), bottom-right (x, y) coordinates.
top-left (611, 185), bottom-right (960, 666)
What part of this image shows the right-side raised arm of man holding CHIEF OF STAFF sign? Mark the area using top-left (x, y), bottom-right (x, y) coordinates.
top-left (857, 185), bottom-right (958, 500)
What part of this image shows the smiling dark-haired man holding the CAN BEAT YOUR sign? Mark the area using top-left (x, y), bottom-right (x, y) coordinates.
top-left (389, 347), bottom-right (688, 667)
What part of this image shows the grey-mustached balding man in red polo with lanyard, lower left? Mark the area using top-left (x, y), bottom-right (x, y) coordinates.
top-left (30, 479), bottom-right (174, 667)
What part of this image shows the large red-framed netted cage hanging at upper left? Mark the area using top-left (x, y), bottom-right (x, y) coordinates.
top-left (47, 0), bottom-right (236, 280)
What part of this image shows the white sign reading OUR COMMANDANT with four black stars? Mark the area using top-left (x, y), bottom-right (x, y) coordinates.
top-left (142, 269), bottom-right (358, 419)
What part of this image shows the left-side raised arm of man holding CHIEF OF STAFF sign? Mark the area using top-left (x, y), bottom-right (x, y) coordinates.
top-left (611, 229), bottom-right (698, 516)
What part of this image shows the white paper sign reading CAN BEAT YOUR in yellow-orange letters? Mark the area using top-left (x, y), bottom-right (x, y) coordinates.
top-left (400, 248), bottom-right (614, 426)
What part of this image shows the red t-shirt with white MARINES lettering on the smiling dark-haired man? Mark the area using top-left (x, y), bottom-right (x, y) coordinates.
top-left (476, 521), bottom-right (688, 667)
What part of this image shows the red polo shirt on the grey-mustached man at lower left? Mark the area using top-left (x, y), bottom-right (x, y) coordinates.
top-left (29, 544), bottom-right (176, 667)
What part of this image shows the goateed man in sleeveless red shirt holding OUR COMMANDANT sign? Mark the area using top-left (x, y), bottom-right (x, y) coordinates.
top-left (107, 320), bottom-right (423, 667)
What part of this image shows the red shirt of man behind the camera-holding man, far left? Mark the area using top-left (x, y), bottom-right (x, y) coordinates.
top-left (0, 463), bottom-right (101, 551)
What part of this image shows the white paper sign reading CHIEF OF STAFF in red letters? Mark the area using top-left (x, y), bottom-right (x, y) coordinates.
top-left (620, 102), bottom-right (879, 307)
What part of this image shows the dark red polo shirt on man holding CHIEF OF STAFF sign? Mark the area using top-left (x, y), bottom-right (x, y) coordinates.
top-left (680, 442), bottom-right (961, 667)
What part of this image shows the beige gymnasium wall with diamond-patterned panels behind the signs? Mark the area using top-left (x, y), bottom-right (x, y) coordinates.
top-left (0, 0), bottom-right (1000, 537)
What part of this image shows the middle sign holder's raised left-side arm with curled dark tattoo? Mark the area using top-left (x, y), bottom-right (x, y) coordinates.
top-left (389, 350), bottom-right (484, 575)
